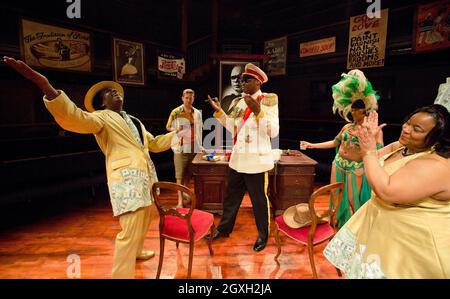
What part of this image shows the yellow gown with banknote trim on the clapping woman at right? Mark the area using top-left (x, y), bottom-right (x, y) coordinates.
top-left (324, 152), bottom-right (450, 278)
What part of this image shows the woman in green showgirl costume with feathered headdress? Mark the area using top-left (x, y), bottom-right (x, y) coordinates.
top-left (300, 70), bottom-right (383, 227)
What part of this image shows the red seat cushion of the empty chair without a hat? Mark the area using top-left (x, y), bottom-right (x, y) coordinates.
top-left (162, 208), bottom-right (214, 241)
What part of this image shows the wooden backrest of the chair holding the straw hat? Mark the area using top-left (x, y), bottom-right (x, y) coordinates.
top-left (308, 182), bottom-right (344, 231)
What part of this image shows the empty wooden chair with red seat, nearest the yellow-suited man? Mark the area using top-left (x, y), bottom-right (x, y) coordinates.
top-left (152, 182), bottom-right (215, 278)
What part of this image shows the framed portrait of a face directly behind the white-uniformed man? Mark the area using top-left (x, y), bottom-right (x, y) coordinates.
top-left (217, 60), bottom-right (260, 112)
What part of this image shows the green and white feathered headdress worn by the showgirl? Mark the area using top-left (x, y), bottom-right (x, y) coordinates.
top-left (331, 70), bottom-right (380, 121)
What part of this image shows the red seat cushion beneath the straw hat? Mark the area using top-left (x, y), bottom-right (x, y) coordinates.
top-left (275, 215), bottom-right (334, 245)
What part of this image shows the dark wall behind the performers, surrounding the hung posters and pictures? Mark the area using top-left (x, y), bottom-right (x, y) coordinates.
top-left (0, 0), bottom-right (450, 227)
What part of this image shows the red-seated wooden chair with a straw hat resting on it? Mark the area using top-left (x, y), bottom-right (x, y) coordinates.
top-left (274, 183), bottom-right (344, 278)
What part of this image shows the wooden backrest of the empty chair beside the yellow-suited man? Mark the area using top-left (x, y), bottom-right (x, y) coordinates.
top-left (152, 182), bottom-right (196, 220)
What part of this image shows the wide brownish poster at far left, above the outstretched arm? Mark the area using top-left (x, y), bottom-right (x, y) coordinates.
top-left (20, 19), bottom-right (92, 72)
